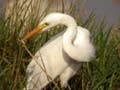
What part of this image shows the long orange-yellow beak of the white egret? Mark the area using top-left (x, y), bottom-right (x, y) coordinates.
top-left (22, 23), bottom-right (48, 41)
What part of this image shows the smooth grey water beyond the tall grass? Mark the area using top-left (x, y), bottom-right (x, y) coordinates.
top-left (0, 0), bottom-right (120, 25)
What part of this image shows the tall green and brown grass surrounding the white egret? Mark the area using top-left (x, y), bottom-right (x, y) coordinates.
top-left (0, 2), bottom-right (120, 90)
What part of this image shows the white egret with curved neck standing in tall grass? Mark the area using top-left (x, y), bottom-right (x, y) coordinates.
top-left (22, 13), bottom-right (95, 90)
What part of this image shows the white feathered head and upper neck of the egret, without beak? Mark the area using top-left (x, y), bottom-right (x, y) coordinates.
top-left (39, 13), bottom-right (77, 31)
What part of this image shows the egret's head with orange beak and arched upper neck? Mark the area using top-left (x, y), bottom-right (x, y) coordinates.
top-left (22, 13), bottom-right (77, 41)
